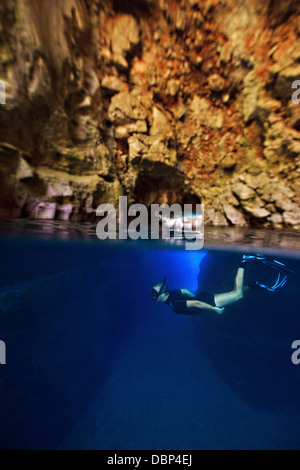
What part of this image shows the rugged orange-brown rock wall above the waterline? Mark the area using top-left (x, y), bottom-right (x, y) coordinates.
top-left (0, 0), bottom-right (300, 229)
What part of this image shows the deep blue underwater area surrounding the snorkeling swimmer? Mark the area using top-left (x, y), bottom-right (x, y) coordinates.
top-left (0, 238), bottom-right (300, 450)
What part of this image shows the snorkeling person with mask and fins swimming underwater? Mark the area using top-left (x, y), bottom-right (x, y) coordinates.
top-left (152, 255), bottom-right (294, 315)
